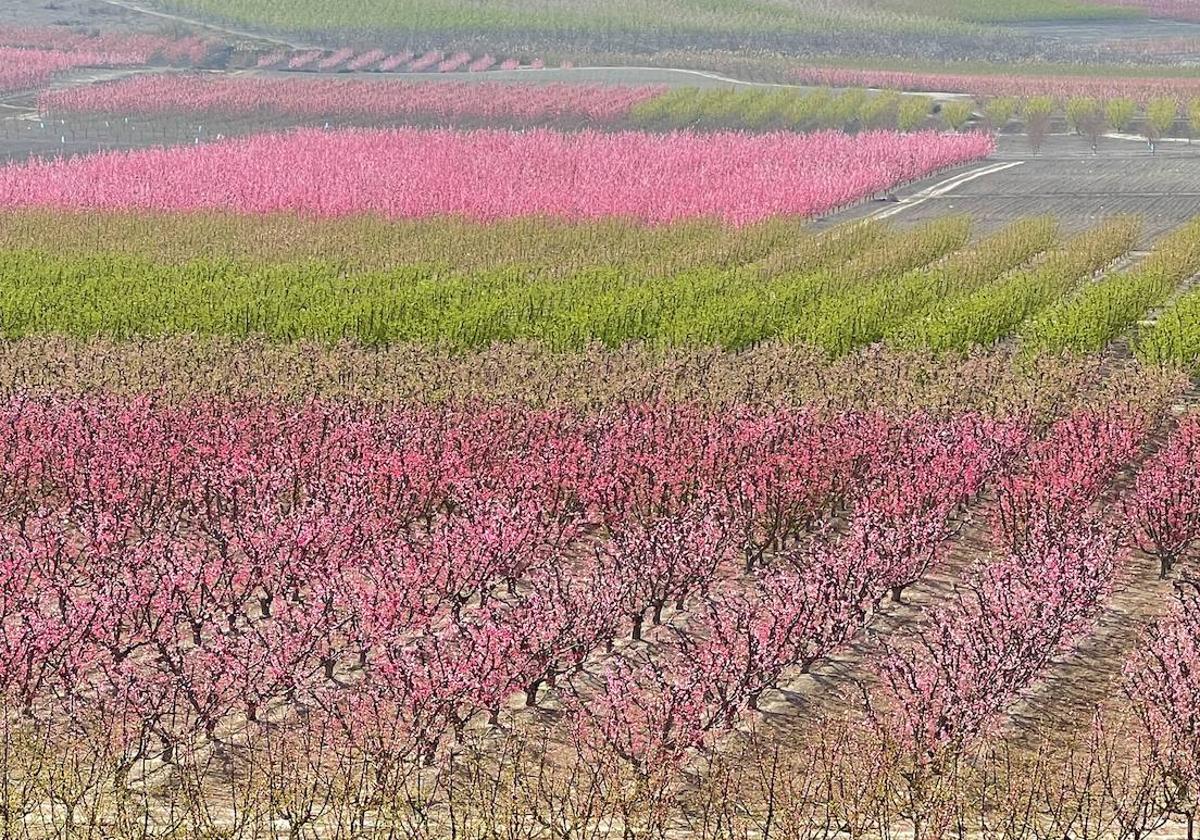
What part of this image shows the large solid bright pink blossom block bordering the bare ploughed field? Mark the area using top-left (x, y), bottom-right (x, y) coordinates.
top-left (0, 123), bottom-right (994, 224)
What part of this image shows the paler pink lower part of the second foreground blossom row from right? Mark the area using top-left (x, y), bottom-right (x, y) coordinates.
top-left (880, 517), bottom-right (1120, 766)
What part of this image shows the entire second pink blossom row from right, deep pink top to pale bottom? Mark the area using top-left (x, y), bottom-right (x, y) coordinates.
top-left (877, 412), bottom-right (1146, 772)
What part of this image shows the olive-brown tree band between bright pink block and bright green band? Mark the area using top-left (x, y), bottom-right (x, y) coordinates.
top-left (0, 210), bottom-right (816, 276)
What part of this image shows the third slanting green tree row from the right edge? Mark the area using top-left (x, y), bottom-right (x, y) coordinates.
top-left (887, 217), bottom-right (1141, 352)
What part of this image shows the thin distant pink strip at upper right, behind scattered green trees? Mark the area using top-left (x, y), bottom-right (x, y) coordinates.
top-left (792, 67), bottom-right (1200, 102)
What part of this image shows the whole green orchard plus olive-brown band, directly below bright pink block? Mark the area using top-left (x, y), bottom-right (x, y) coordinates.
top-left (0, 208), bottom-right (1180, 360)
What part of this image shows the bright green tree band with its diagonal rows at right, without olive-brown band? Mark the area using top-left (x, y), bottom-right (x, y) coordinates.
top-left (0, 210), bottom-right (1180, 357)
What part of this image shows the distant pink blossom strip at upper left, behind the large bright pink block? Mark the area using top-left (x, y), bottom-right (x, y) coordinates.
top-left (38, 74), bottom-right (665, 120)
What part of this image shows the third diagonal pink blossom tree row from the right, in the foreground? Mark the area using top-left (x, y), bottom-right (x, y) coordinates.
top-left (568, 416), bottom-right (1028, 772)
